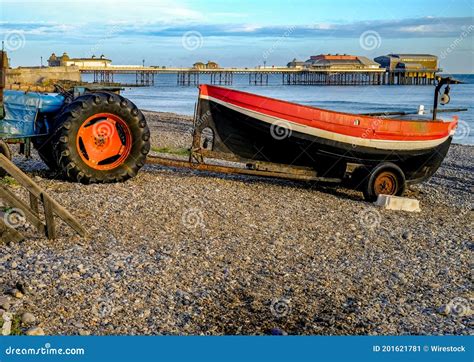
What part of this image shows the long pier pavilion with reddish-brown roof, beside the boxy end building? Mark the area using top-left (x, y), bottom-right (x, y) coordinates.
top-left (305, 54), bottom-right (380, 70)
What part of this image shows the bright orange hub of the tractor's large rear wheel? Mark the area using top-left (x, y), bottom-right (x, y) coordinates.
top-left (76, 113), bottom-right (132, 171)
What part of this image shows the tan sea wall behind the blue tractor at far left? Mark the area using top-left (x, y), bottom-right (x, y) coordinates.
top-left (6, 66), bottom-right (81, 86)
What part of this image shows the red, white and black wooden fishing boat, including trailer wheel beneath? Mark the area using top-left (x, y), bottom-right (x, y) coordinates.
top-left (186, 80), bottom-right (457, 199)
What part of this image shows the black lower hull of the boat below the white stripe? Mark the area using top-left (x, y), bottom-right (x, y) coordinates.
top-left (197, 99), bottom-right (452, 182)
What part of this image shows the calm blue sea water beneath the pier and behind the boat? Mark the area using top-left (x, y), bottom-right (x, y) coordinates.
top-left (83, 74), bottom-right (474, 145)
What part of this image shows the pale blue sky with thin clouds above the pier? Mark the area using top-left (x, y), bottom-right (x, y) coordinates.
top-left (0, 0), bottom-right (474, 73)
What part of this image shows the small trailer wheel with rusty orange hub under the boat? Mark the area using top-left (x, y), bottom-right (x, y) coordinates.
top-left (363, 162), bottom-right (406, 201)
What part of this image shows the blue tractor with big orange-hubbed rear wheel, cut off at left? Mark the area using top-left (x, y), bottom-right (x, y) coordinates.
top-left (0, 51), bottom-right (150, 184)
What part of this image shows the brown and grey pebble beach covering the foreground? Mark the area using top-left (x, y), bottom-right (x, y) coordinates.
top-left (0, 111), bottom-right (474, 335)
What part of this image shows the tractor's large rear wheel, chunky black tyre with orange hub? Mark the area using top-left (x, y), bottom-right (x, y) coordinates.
top-left (53, 92), bottom-right (150, 184)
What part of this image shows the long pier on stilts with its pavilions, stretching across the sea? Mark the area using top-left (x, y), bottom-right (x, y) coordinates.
top-left (42, 52), bottom-right (440, 86)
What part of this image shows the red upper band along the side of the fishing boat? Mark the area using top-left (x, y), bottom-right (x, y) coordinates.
top-left (199, 85), bottom-right (458, 143)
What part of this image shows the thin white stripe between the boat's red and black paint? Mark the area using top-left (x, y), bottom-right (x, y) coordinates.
top-left (200, 95), bottom-right (449, 151)
